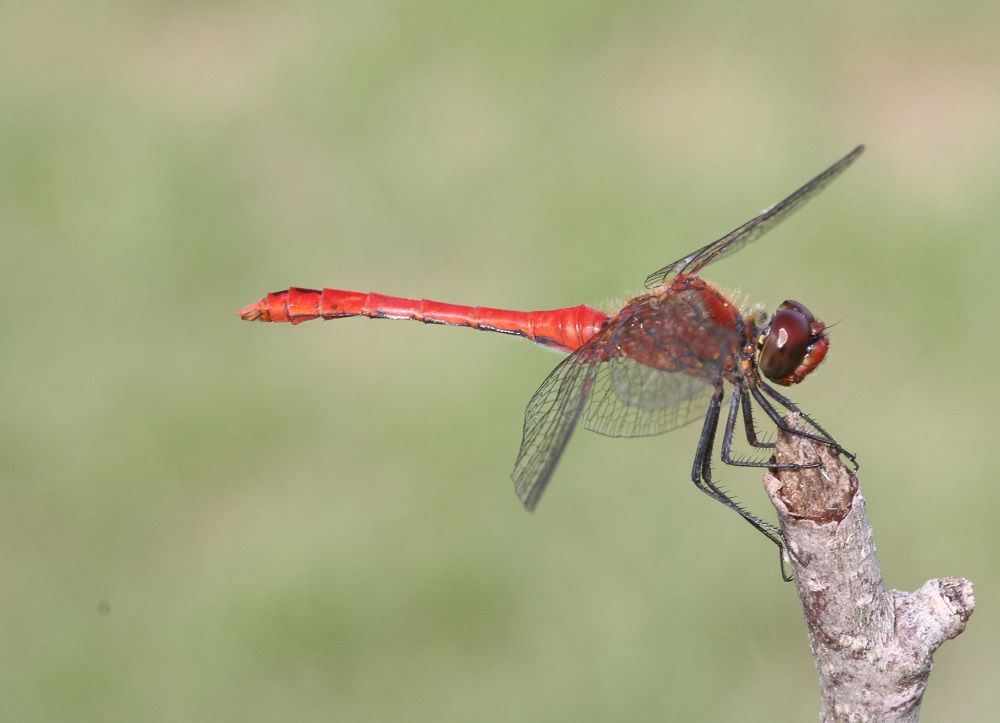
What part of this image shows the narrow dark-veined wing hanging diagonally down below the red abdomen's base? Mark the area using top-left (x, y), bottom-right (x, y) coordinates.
top-left (511, 339), bottom-right (601, 510)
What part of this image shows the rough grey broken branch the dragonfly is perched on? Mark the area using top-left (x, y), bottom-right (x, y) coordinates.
top-left (764, 414), bottom-right (975, 722)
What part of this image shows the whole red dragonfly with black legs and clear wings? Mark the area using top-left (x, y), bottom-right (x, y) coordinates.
top-left (239, 146), bottom-right (864, 549)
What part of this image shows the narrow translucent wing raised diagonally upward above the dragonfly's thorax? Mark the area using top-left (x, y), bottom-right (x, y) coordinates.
top-left (646, 146), bottom-right (865, 289)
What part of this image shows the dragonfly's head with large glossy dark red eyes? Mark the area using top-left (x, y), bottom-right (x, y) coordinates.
top-left (757, 301), bottom-right (830, 387)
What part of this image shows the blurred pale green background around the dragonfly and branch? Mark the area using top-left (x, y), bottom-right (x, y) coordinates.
top-left (0, 1), bottom-right (1000, 721)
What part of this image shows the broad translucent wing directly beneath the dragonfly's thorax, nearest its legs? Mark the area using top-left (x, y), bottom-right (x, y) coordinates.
top-left (583, 357), bottom-right (713, 437)
